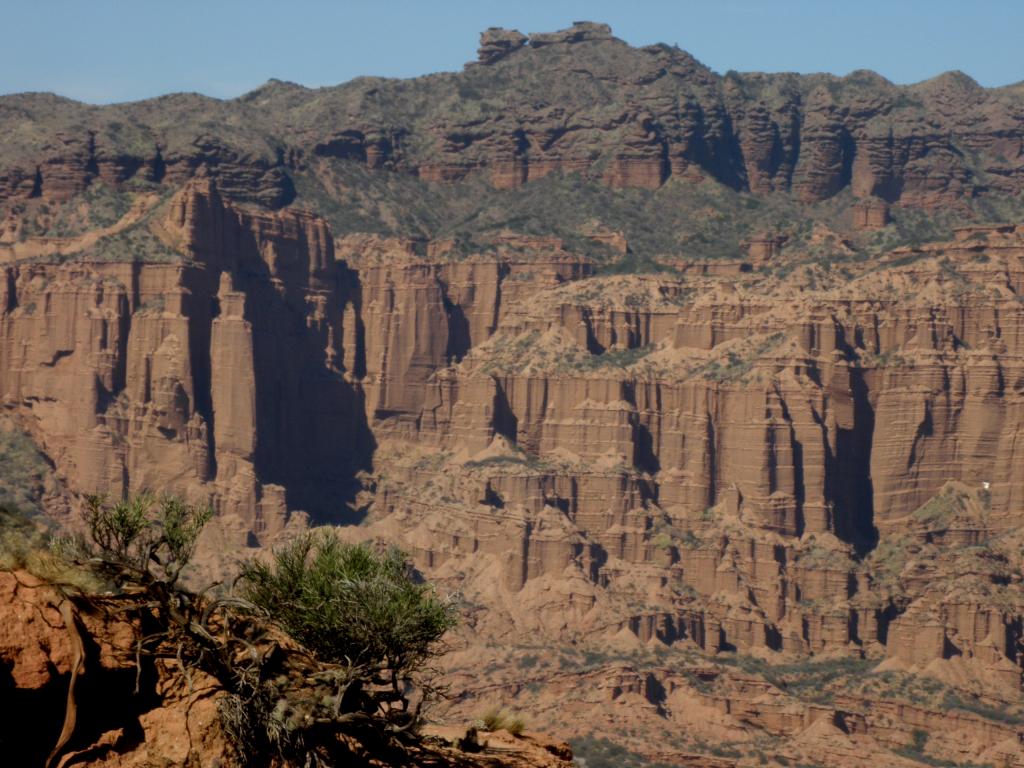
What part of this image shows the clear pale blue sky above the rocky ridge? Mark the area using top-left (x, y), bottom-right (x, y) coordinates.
top-left (0, 0), bottom-right (1024, 102)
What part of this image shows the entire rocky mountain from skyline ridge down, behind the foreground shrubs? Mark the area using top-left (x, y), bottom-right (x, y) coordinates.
top-left (0, 23), bottom-right (1024, 766)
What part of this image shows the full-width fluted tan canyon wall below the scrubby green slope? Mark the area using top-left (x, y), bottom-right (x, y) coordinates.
top-left (8, 185), bottom-right (1024, 692)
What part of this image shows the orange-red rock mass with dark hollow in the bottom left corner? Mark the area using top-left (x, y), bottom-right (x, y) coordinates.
top-left (0, 571), bottom-right (226, 768)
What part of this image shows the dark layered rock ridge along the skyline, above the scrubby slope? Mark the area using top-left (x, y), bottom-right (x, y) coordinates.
top-left (0, 23), bottom-right (1024, 211)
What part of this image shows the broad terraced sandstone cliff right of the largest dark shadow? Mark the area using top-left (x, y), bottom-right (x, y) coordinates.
top-left (335, 227), bottom-right (1024, 765)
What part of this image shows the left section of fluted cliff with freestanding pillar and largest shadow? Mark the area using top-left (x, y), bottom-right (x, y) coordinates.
top-left (0, 180), bottom-right (362, 535)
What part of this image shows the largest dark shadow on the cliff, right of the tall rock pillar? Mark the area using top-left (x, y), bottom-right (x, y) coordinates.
top-left (236, 231), bottom-right (376, 524)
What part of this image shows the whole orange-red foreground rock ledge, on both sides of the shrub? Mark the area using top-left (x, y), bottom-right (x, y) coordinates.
top-left (0, 570), bottom-right (572, 768)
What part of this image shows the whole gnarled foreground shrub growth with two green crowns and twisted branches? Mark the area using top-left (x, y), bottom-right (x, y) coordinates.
top-left (54, 495), bottom-right (456, 766)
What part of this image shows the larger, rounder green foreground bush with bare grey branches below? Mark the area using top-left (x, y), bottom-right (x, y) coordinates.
top-left (221, 534), bottom-right (456, 765)
